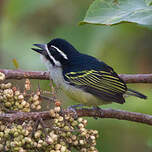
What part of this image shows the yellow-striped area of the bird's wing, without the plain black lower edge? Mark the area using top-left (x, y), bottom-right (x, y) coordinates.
top-left (66, 70), bottom-right (126, 95)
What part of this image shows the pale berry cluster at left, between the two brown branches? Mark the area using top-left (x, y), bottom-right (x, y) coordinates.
top-left (0, 73), bottom-right (41, 112)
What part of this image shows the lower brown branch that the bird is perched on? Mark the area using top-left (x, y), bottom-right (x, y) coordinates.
top-left (0, 108), bottom-right (152, 125)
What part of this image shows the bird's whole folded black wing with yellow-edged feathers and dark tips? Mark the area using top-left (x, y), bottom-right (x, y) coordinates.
top-left (64, 70), bottom-right (127, 103)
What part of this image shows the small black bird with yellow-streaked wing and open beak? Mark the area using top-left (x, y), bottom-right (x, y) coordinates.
top-left (32, 38), bottom-right (147, 107)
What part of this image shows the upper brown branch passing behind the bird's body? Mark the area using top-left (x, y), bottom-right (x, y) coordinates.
top-left (0, 69), bottom-right (152, 83)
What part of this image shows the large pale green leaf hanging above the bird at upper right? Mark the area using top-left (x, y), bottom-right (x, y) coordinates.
top-left (80, 0), bottom-right (152, 26)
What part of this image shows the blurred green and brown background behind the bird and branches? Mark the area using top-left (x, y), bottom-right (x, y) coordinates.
top-left (0, 0), bottom-right (152, 152)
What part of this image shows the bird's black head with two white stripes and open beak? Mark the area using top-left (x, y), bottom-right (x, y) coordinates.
top-left (32, 38), bottom-right (80, 67)
